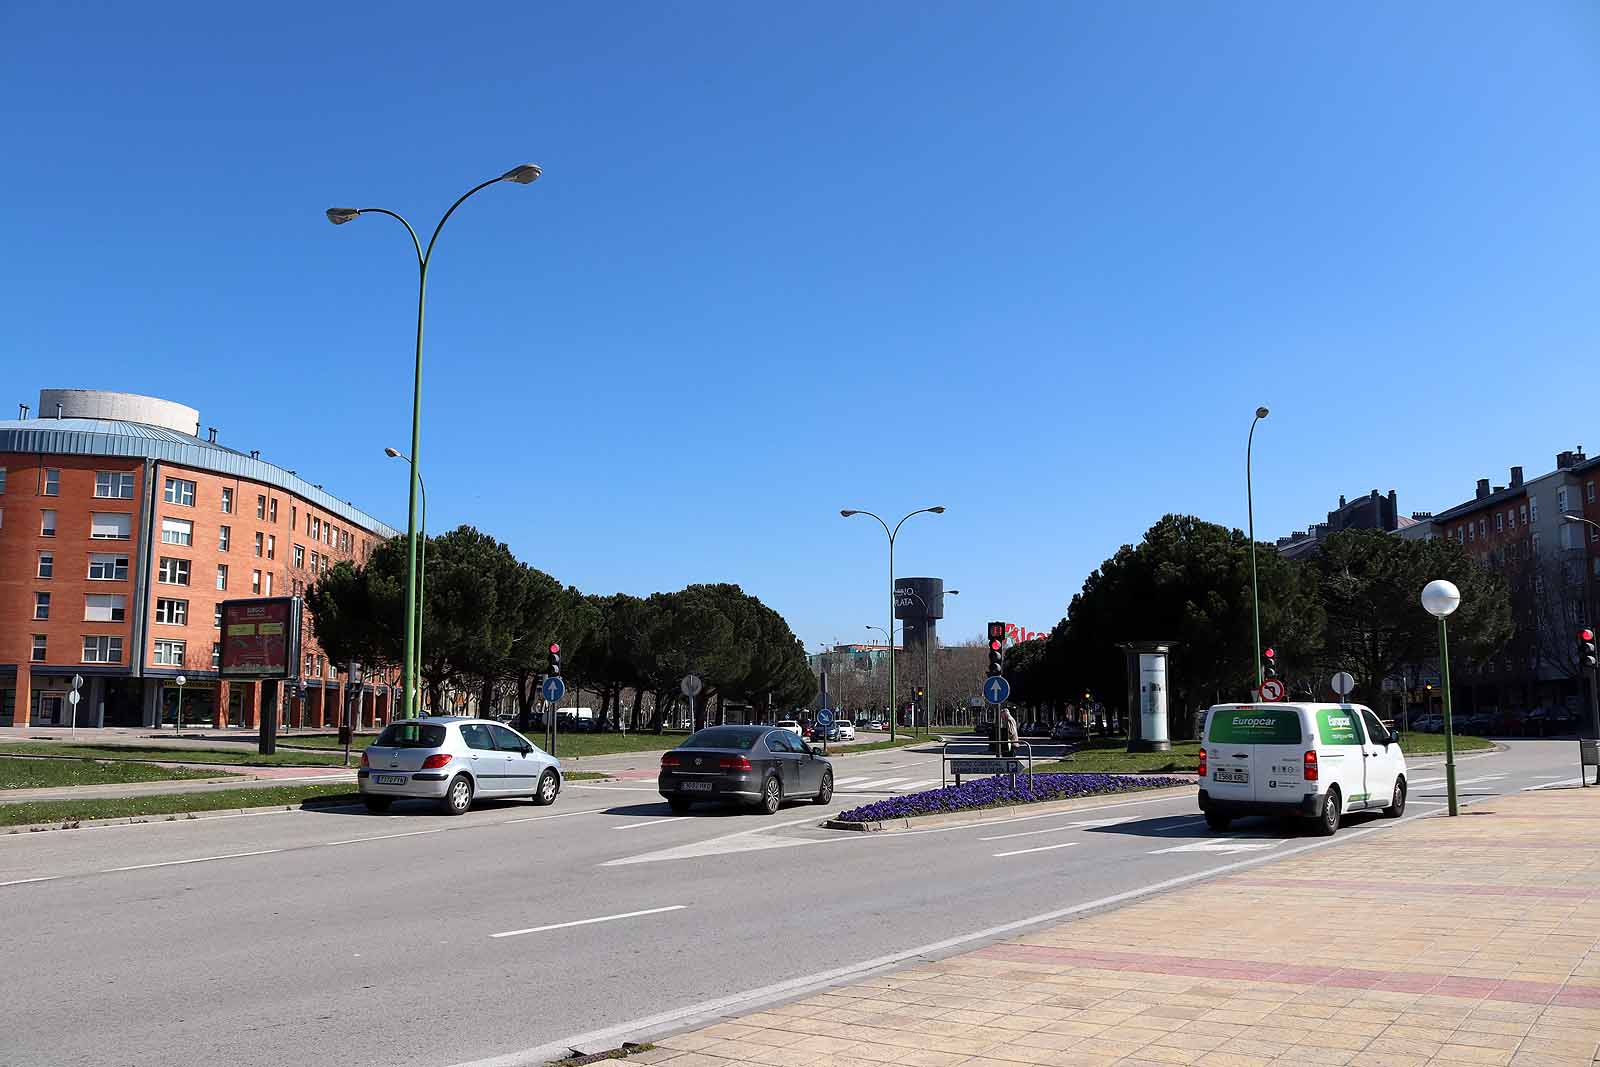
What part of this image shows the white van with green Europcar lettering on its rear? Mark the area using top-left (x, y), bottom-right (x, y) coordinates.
top-left (1200, 704), bottom-right (1406, 835)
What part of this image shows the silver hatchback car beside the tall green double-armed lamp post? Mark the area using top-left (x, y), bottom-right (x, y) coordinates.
top-left (357, 715), bottom-right (562, 816)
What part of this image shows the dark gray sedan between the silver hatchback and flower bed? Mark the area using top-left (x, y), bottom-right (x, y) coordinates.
top-left (659, 726), bottom-right (834, 814)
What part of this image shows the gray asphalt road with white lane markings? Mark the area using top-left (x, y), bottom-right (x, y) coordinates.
top-left (0, 741), bottom-right (1578, 1065)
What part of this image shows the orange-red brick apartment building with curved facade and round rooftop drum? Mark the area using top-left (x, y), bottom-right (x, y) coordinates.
top-left (0, 389), bottom-right (397, 728)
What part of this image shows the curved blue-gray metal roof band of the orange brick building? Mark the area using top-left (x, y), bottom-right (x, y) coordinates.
top-left (0, 419), bottom-right (400, 537)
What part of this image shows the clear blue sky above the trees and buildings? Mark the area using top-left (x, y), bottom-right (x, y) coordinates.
top-left (0, 0), bottom-right (1600, 648)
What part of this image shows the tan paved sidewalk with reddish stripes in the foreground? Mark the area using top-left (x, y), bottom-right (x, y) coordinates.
top-left (626, 789), bottom-right (1600, 1067)
